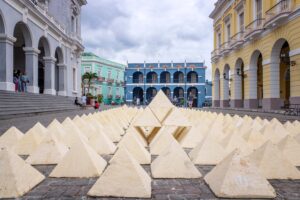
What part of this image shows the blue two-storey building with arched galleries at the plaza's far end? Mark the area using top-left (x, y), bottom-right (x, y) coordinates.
top-left (125, 62), bottom-right (211, 107)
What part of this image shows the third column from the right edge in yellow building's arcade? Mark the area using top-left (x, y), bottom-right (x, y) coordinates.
top-left (244, 67), bottom-right (258, 109)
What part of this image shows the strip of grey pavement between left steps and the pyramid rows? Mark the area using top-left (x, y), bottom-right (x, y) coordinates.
top-left (0, 106), bottom-right (117, 135)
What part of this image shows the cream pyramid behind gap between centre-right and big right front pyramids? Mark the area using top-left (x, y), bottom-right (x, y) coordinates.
top-left (189, 136), bottom-right (227, 165)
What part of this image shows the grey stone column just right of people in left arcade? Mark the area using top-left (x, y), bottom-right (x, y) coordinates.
top-left (23, 47), bottom-right (40, 93)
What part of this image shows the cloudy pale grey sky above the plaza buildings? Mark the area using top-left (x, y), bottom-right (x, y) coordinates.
top-left (81, 0), bottom-right (215, 80)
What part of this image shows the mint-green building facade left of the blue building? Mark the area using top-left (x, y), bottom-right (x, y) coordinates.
top-left (81, 53), bottom-right (126, 104)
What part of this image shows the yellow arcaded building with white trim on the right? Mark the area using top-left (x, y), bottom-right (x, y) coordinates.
top-left (210, 0), bottom-right (300, 110)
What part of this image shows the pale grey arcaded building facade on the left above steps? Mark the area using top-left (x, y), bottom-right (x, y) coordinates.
top-left (0, 0), bottom-right (87, 97)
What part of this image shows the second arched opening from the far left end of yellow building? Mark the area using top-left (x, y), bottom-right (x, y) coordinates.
top-left (222, 64), bottom-right (231, 107)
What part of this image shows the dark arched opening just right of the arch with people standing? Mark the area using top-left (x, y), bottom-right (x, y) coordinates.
top-left (38, 37), bottom-right (51, 93)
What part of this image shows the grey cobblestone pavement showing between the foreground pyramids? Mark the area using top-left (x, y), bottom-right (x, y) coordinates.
top-left (20, 156), bottom-right (300, 200)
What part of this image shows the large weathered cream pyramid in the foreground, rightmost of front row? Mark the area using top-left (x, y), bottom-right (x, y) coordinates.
top-left (204, 151), bottom-right (276, 198)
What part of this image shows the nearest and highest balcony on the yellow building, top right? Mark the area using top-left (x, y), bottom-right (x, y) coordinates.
top-left (265, 0), bottom-right (291, 28)
